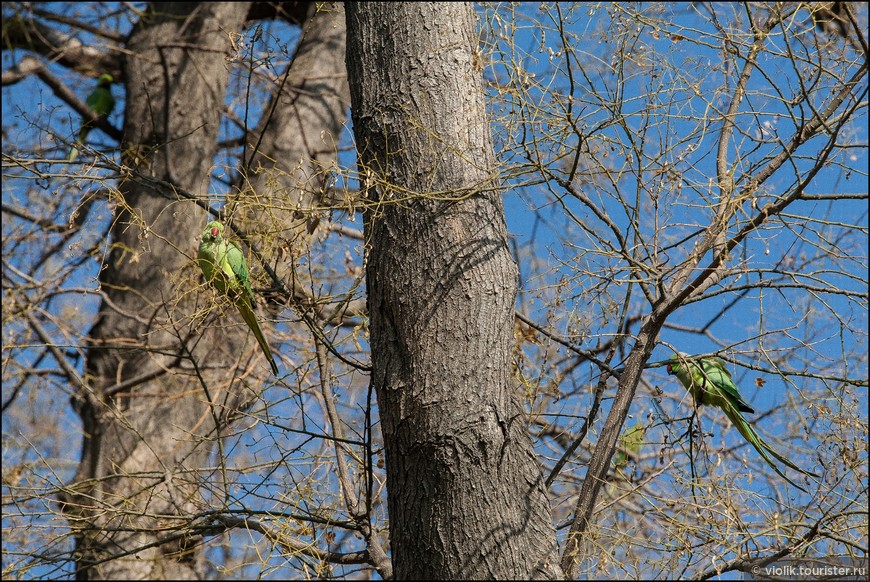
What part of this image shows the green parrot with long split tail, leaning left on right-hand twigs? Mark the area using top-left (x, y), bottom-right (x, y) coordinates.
top-left (667, 352), bottom-right (818, 491)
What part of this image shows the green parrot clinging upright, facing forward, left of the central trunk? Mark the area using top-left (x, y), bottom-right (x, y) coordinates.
top-left (197, 220), bottom-right (278, 376)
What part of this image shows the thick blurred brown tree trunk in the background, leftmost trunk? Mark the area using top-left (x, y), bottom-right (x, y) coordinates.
top-left (65, 3), bottom-right (250, 580)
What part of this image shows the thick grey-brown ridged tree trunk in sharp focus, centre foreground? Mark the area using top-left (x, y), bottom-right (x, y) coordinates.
top-left (347, 2), bottom-right (561, 579)
